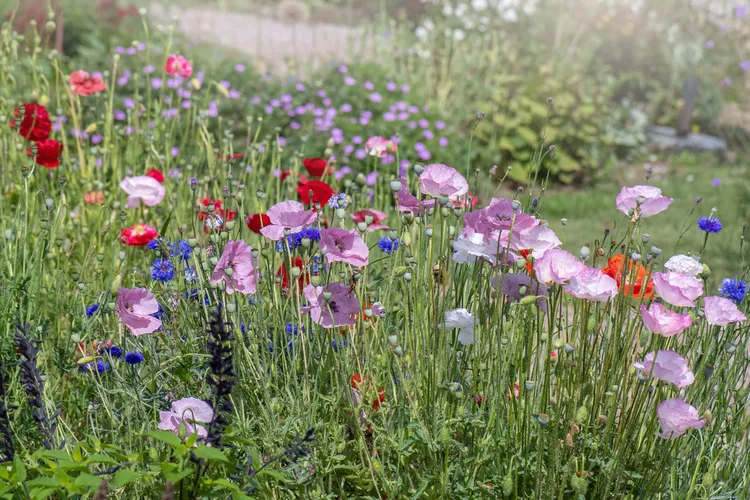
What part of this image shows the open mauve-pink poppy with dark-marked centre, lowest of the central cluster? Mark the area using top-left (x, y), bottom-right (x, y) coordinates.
top-left (302, 283), bottom-right (359, 328)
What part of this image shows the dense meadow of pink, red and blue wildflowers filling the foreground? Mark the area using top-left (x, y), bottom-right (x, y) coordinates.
top-left (0, 1), bottom-right (750, 500)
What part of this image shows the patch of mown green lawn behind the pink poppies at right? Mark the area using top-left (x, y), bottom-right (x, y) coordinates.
top-left (541, 160), bottom-right (750, 286)
